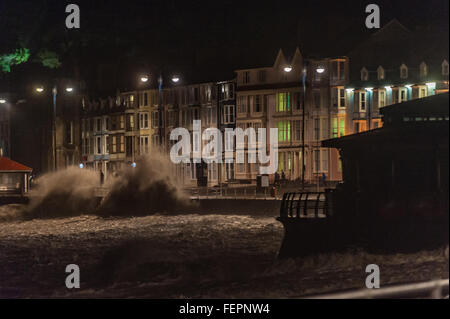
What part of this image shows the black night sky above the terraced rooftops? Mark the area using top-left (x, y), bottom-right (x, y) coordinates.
top-left (0, 0), bottom-right (449, 95)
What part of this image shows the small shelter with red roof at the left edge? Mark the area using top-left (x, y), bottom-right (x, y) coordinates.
top-left (0, 157), bottom-right (32, 196)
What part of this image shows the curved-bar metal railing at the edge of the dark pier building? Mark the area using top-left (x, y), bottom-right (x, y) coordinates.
top-left (280, 192), bottom-right (330, 218)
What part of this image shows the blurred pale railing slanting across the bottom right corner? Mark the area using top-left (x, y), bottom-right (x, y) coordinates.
top-left (304, 279), bottom-right (449, 299)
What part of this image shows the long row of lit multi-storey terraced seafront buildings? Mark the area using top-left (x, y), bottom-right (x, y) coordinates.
top-left (77, 20), bottom-right (449, 186)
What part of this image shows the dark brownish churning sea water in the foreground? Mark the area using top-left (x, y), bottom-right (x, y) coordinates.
top-left (0, 213), bottom-right (449, 298)
